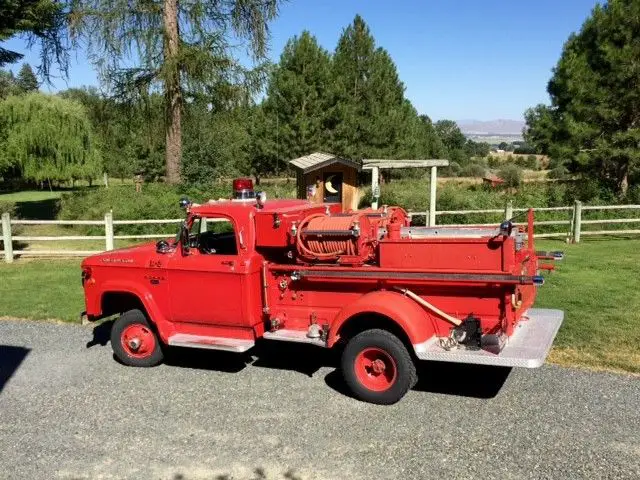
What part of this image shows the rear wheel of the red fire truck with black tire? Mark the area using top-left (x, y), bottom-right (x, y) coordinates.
top-left (341, 329), bottom-right (418, 405)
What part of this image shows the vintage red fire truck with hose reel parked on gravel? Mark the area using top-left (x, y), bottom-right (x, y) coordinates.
top-left (82, 180), bottom-right (563, 404)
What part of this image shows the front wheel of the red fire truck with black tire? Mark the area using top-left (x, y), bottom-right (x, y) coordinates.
top-left (111, 309), bottom-right (164, 367)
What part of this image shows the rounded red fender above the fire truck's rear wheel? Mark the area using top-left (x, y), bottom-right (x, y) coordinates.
top-left (327, 290), bottom-right (435, 347)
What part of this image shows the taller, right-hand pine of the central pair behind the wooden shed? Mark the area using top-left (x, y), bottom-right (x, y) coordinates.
top-left (262, 31), bottom-right (331, 163)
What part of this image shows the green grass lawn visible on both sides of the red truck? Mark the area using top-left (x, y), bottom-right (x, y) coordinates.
top-left (0, 239), bottom-right (640, 373)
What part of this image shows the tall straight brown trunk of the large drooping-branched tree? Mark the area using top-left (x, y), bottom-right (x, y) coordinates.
top-left (164, 0), bottom-right (182, 183)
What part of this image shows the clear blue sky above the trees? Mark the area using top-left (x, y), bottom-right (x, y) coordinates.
top-left (4, 0), bottom-right (598, 120)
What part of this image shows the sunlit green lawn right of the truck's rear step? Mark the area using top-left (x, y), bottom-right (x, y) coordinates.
top-left (536, 238), bottom-right (640, 373)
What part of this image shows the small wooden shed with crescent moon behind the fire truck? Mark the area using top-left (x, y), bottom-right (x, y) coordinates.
top-left (289, 152), bottom-right (362, 211)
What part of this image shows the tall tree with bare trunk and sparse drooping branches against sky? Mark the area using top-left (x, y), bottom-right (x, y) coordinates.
top-left (71, 0), bottom-right (278, 183)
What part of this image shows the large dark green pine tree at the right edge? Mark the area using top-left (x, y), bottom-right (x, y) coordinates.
top-left (525, 0), bottom-right (640, 196)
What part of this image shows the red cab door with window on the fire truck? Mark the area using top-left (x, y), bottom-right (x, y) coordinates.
top-left (168, 218), bottom-right (248, 326)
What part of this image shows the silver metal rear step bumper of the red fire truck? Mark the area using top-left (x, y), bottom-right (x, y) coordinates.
top-left (413, 308), bottom-right (564, 368)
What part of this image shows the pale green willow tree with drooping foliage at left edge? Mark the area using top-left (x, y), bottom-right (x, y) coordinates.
top-left (0, 93), bottom-right (102, 182)
